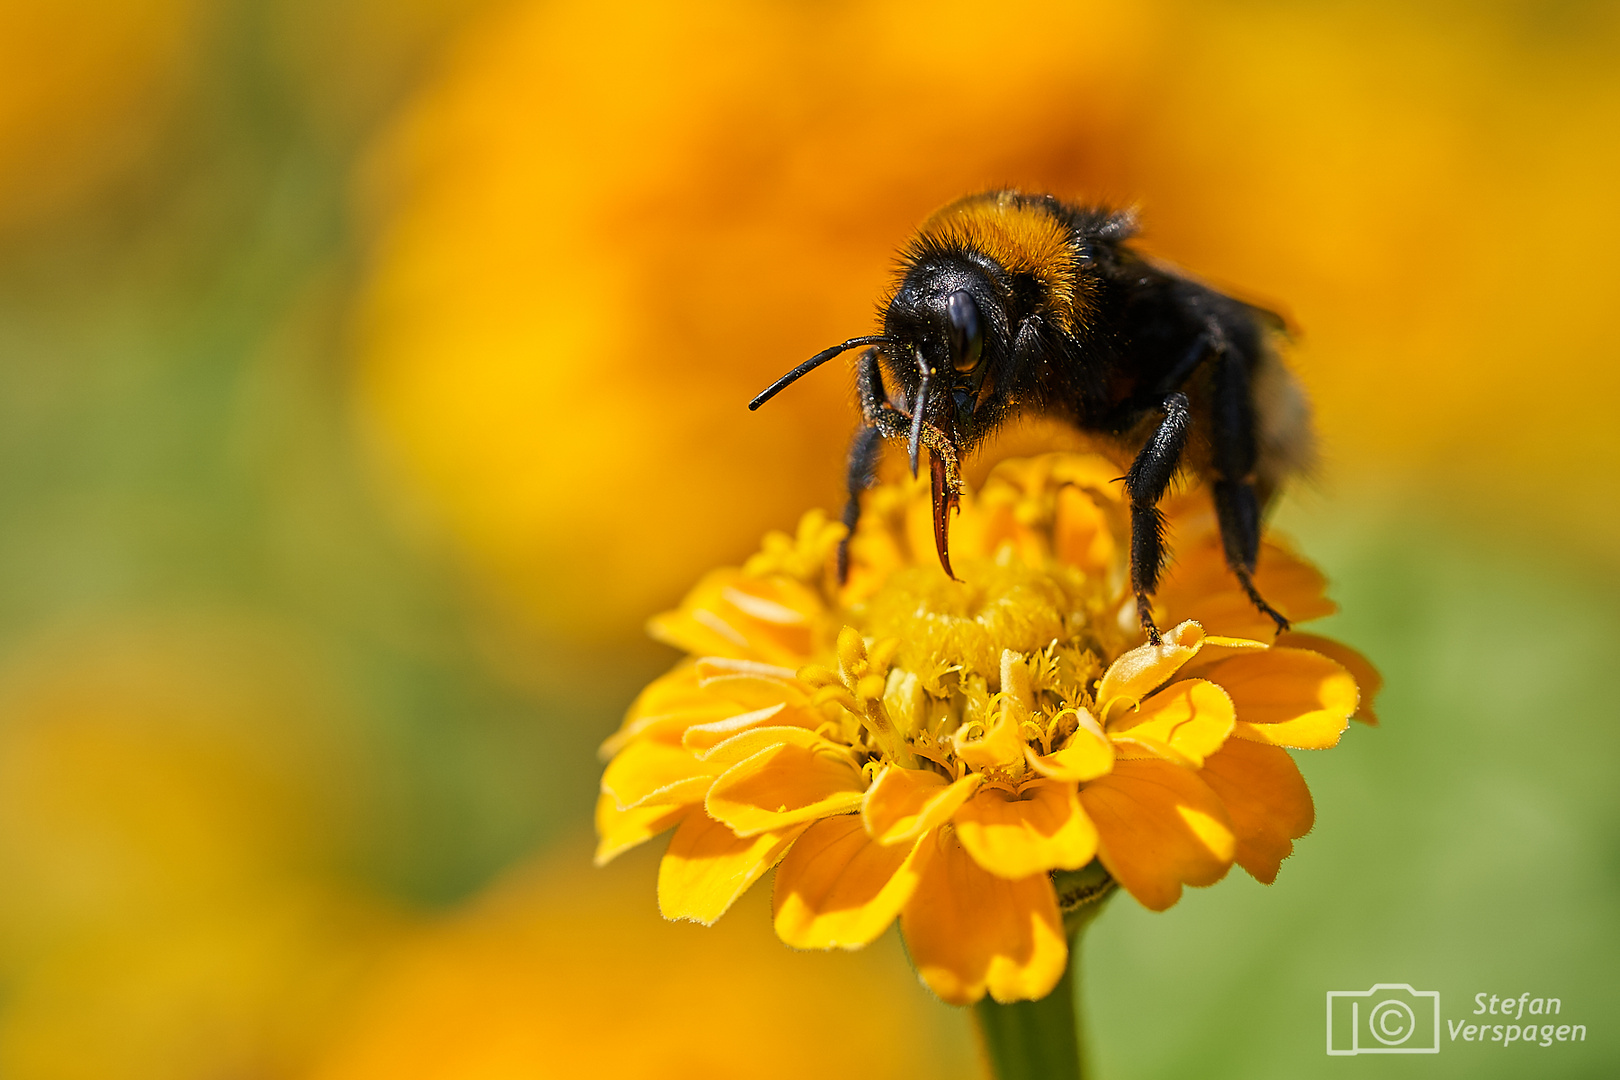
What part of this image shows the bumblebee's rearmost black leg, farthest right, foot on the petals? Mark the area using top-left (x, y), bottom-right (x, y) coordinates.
top-left (1210, 350), bottom-right (1288, 633)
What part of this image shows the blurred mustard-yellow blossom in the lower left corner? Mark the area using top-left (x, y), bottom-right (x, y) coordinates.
top-left (0, 620), bottom-right (402, 1080)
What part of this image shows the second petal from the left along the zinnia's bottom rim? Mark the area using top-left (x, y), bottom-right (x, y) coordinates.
top-left (658, 813), bottom-right (808, 926)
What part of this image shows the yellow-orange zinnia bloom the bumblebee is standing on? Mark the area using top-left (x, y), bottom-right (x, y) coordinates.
top-left (596, 453), bottom-right (1371, 1004)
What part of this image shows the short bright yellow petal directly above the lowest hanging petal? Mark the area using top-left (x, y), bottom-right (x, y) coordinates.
top-left (954, 780), bottom-right (1097, 881)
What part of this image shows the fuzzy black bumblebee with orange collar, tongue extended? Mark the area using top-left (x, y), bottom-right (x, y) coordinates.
top-left (748, 191), bottom-right (1312, 644)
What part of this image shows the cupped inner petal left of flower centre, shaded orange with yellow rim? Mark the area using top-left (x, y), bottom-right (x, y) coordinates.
top-left (703, 729), bottom-right (865, 836)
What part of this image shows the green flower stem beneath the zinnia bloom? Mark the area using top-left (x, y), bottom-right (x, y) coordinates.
top-left (974, 863), bottom-right (1115, 1080)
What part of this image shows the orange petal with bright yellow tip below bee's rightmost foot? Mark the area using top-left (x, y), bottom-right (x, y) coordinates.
top-left (1207, 646), bottom-right (1358, 750)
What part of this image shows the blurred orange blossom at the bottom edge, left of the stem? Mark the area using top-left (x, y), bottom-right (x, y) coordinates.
top-left (313, 850), bottom-right (977, 1080)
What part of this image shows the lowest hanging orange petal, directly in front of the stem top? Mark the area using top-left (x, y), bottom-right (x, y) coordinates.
top-left (901, 827), bottom-right (1069, 1006)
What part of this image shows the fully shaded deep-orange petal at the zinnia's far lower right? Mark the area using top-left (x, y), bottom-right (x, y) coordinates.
top-left (1199, 738), bottom-right (1315, 884)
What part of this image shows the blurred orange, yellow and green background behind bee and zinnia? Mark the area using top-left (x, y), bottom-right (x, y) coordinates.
top-left (0, 0), bottom-right (1620, 1080)
